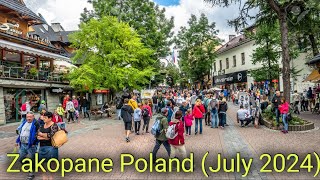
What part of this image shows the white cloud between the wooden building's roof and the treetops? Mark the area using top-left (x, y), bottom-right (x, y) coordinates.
top-left (25, 0), bottom-right (92, 30)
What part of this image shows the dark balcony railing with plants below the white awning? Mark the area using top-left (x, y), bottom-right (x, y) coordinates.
top-left (0, 65), bottom-right (68, 83)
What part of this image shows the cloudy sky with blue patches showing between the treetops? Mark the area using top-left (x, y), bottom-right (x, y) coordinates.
top-left (25, 0), bottom-right (245, 40)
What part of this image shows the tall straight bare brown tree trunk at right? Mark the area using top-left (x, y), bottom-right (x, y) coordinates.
top-left (278, 10), bottom-right (291, 104)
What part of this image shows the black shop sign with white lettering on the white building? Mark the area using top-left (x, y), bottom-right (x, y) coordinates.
top-left (214, 71), bottom-right (247, 85)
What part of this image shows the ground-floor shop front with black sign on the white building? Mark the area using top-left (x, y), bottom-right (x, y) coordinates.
top-left (213, 71), bottom-right (248, 90)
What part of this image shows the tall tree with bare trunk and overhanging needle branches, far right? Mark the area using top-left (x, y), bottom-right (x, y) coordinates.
top-left (204, 0), bottom-right (319, 102)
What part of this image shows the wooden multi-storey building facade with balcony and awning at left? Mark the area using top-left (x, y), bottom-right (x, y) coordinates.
top-left (0, 0), bottom-right (72, 125)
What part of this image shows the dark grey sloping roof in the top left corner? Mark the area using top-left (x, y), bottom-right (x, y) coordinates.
top-left (0, 0), bottom-right (45, 24)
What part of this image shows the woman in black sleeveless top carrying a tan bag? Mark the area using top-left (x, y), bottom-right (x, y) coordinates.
top-left (37, 112), bottom-right (59, 179)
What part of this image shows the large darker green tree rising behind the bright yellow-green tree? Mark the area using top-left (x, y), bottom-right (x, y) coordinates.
top-left (81, 0), bottom-right (174, 59)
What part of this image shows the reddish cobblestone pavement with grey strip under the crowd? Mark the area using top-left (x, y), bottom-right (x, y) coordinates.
top-left (0, 104), bottom-right (320, 179)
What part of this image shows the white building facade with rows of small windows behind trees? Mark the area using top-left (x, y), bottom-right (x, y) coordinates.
top-left (212, 35), bottom-right (313, 92)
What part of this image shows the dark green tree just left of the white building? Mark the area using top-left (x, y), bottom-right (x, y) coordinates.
top-left (175, 14), bottom-right (219, 81)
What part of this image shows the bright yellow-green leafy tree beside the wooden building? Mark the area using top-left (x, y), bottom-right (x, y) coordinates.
top-left (69, 16), bottom-right (154, 91)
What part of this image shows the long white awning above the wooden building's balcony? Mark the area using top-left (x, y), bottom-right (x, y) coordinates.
top-left (0, 39), bottom-right (70, 62)
